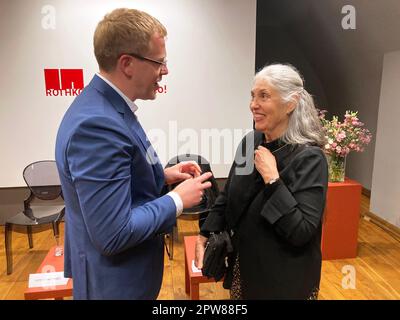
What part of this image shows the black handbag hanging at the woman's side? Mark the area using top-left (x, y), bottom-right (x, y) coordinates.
top-left (201, 231), bottom-right (233, 281)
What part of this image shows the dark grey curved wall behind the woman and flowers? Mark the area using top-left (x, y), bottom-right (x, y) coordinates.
top-left (256, 0), bottom-right (400, 189)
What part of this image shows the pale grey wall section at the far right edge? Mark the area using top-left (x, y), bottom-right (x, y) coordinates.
top-left (370, 51), bottom-right (400, 227)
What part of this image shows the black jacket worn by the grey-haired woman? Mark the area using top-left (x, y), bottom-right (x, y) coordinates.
top-left (201, 131), bottom-right (328, 299)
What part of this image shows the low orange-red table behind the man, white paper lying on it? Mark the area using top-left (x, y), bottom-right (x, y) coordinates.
top-left (24, 246), bottom-right (72, 300)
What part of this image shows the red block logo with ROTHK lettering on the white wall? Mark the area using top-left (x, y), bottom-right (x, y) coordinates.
top-left (44, 69), bottom-right (84, 97)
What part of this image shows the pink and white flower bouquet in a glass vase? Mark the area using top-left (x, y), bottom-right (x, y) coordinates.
top-left (319, 110), bottom-right (372, 182)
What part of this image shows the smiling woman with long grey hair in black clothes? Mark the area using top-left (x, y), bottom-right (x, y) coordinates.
top-left (195, 64), bottom-right (328, 299)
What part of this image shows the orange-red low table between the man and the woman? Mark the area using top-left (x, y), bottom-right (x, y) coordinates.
top-left (183, 236), bottom-right (220, 300)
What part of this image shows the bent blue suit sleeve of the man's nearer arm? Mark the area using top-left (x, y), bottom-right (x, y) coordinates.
top-left (66, 116), bottom-right (176, 255)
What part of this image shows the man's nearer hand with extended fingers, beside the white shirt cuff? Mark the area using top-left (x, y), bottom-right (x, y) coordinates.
top-left (173, 172), bottom-right (212, 209)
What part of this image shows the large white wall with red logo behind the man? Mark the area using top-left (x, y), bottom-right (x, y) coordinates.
top-left (0, 0), bottom-right (256, 187)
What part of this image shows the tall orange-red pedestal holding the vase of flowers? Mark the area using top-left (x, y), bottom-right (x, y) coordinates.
top-left (321, 179), bottom-right (361, 260)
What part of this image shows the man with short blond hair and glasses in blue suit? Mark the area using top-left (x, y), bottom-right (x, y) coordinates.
top-left (56, 9), bottom-right (211, 299)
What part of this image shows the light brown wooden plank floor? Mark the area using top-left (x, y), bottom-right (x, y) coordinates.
top-left (0, 196), bottom-right (400, 300)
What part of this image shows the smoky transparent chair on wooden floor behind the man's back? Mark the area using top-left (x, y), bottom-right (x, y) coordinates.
top-left (5, 160), bottom-right (65, 274)
